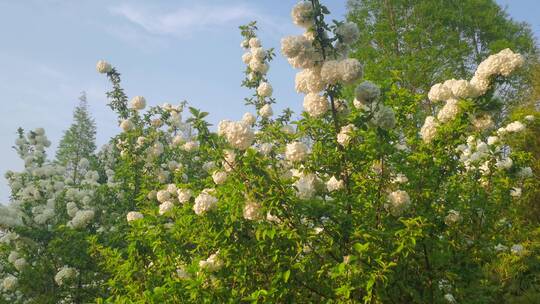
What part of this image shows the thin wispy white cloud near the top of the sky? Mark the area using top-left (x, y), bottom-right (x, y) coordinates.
top-left (109, 4), bottom-right (258, 36)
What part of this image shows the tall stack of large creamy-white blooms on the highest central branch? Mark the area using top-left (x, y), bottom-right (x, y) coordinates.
top-left (281, 1), bottom-right (363, 117)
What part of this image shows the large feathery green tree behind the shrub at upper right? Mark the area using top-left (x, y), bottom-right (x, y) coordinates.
top-left (348, 0), bottom-right (537, 103)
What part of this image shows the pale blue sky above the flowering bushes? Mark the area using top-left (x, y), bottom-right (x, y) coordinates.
top-left (0, 0), bottom-right (540, 203)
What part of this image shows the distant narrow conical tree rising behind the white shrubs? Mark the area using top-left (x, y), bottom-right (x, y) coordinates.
top-left (56, 92), bottom-right (96, 183)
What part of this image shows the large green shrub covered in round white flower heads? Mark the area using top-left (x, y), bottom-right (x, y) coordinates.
top-left (2, 0), bottom-right (539, 303)
